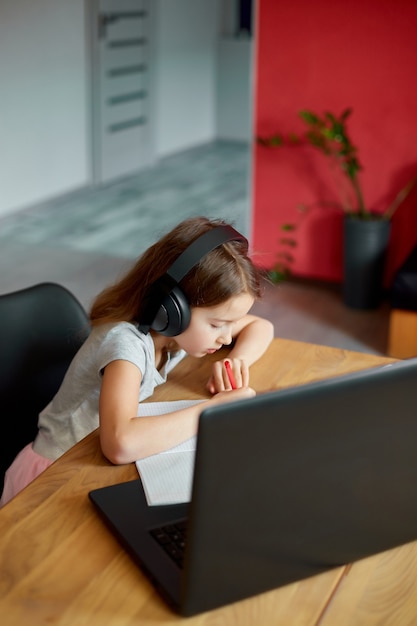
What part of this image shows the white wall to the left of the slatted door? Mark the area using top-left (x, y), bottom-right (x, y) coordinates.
top-left (0, 0), bottom-right (89, 214)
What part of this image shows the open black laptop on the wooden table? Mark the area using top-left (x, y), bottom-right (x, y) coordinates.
top-left (89, 359), bottom-right (417, 616)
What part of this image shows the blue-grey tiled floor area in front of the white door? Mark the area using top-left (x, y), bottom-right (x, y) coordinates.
top-left (0, 142), bottom-right (250, 259)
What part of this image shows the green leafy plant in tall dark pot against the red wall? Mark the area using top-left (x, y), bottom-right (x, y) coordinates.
top-left (258, 108), bottom-right (417, 308)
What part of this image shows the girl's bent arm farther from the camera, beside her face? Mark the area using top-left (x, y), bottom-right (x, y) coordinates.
top-left (207, 315), bottom-right (274, 393)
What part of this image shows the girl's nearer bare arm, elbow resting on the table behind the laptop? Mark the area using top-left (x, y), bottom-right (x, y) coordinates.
top-left (99, 360), bottom-right (255, 465)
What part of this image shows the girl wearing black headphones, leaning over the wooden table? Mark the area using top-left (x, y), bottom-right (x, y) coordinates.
top-left (1, 217), bottom-right (273, 505)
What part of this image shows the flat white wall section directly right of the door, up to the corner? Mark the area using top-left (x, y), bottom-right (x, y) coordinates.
top-left (154, 0), bottom-right (219, 157)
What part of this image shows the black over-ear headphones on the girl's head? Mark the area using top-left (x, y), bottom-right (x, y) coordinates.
top-left (139, 224), bottom-right (248, 337)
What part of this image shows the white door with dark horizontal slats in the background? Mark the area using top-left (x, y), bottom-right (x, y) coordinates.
top-left (93, 0), bottom-right (154, 183)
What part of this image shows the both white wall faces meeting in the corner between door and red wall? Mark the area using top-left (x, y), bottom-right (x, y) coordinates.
top-left (154, 0), bottom-right (252, 158)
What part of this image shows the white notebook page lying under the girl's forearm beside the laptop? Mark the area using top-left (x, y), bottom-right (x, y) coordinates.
top-left (136, 400), bottom-right (201, 506)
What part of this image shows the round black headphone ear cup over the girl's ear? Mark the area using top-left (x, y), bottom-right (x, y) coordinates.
top-left (151, 287), bottom-right (191, 337)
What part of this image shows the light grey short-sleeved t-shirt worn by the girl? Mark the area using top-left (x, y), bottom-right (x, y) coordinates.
top-left (33, 322), bottom-right (186, 460)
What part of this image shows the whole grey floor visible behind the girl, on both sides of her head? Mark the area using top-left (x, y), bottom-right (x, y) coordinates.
top-left (0, 142), bottom-right (389, 354)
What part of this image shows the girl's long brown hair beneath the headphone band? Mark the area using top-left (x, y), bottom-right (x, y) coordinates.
top-left (90, 217), bottom-right (261, 325)
